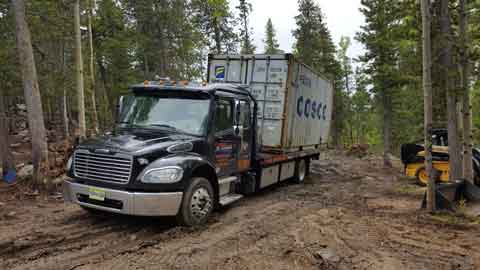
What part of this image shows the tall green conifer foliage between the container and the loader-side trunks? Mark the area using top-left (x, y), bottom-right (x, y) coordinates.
top-left (356, 0), bottom-right (423, 152)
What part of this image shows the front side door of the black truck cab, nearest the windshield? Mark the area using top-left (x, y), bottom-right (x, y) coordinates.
top-left (214, 96), bottom-right (239, 176)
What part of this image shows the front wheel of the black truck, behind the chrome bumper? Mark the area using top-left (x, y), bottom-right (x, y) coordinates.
top-left (177, 177), bottom-right (215, 227)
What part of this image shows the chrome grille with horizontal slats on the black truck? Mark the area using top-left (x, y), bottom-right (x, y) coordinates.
top-left (73, 150), bottom-right (132, 184)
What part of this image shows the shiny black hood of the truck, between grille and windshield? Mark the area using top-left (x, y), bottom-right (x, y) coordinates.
top-left (78, 130), bottom-right (199, 155)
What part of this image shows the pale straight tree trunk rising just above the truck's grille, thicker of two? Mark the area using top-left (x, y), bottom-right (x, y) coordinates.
top-left (73, 0), bottom-right (86, 138)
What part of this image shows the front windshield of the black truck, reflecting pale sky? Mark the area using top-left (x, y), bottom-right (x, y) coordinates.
top-left (118, 95), bottom-right (210, 136)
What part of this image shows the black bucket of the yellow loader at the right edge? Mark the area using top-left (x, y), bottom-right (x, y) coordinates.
top-left (422, 180), bottom-right (480, 217)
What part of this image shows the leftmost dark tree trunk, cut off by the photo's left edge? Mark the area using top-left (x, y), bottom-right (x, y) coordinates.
top-left (0, 90), bottom-right (15, 177)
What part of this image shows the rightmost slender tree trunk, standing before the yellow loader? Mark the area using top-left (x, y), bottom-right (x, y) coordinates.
top-left (459, 0), bottom-right (474, 182)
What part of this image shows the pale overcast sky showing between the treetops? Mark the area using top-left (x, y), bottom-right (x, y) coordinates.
top-left (230, 0), bottom-right (364, 58)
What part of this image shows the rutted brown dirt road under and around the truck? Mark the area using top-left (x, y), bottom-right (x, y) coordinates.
top-left (0, 155), bottom-right (480, 270)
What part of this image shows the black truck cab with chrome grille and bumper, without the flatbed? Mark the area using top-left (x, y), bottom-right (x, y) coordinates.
top-left (64, 82), bottom-right (316, 225)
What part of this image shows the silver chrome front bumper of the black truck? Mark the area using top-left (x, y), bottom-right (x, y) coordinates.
top-left (63, 180), bottom-right (183, 216)
